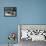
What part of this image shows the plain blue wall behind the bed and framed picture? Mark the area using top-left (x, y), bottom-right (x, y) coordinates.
top-left (0, 0), bottom-right (46, 44)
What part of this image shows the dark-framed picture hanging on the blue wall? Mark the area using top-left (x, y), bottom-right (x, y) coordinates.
top-left (4, 7), bottom-right (16, 17)
